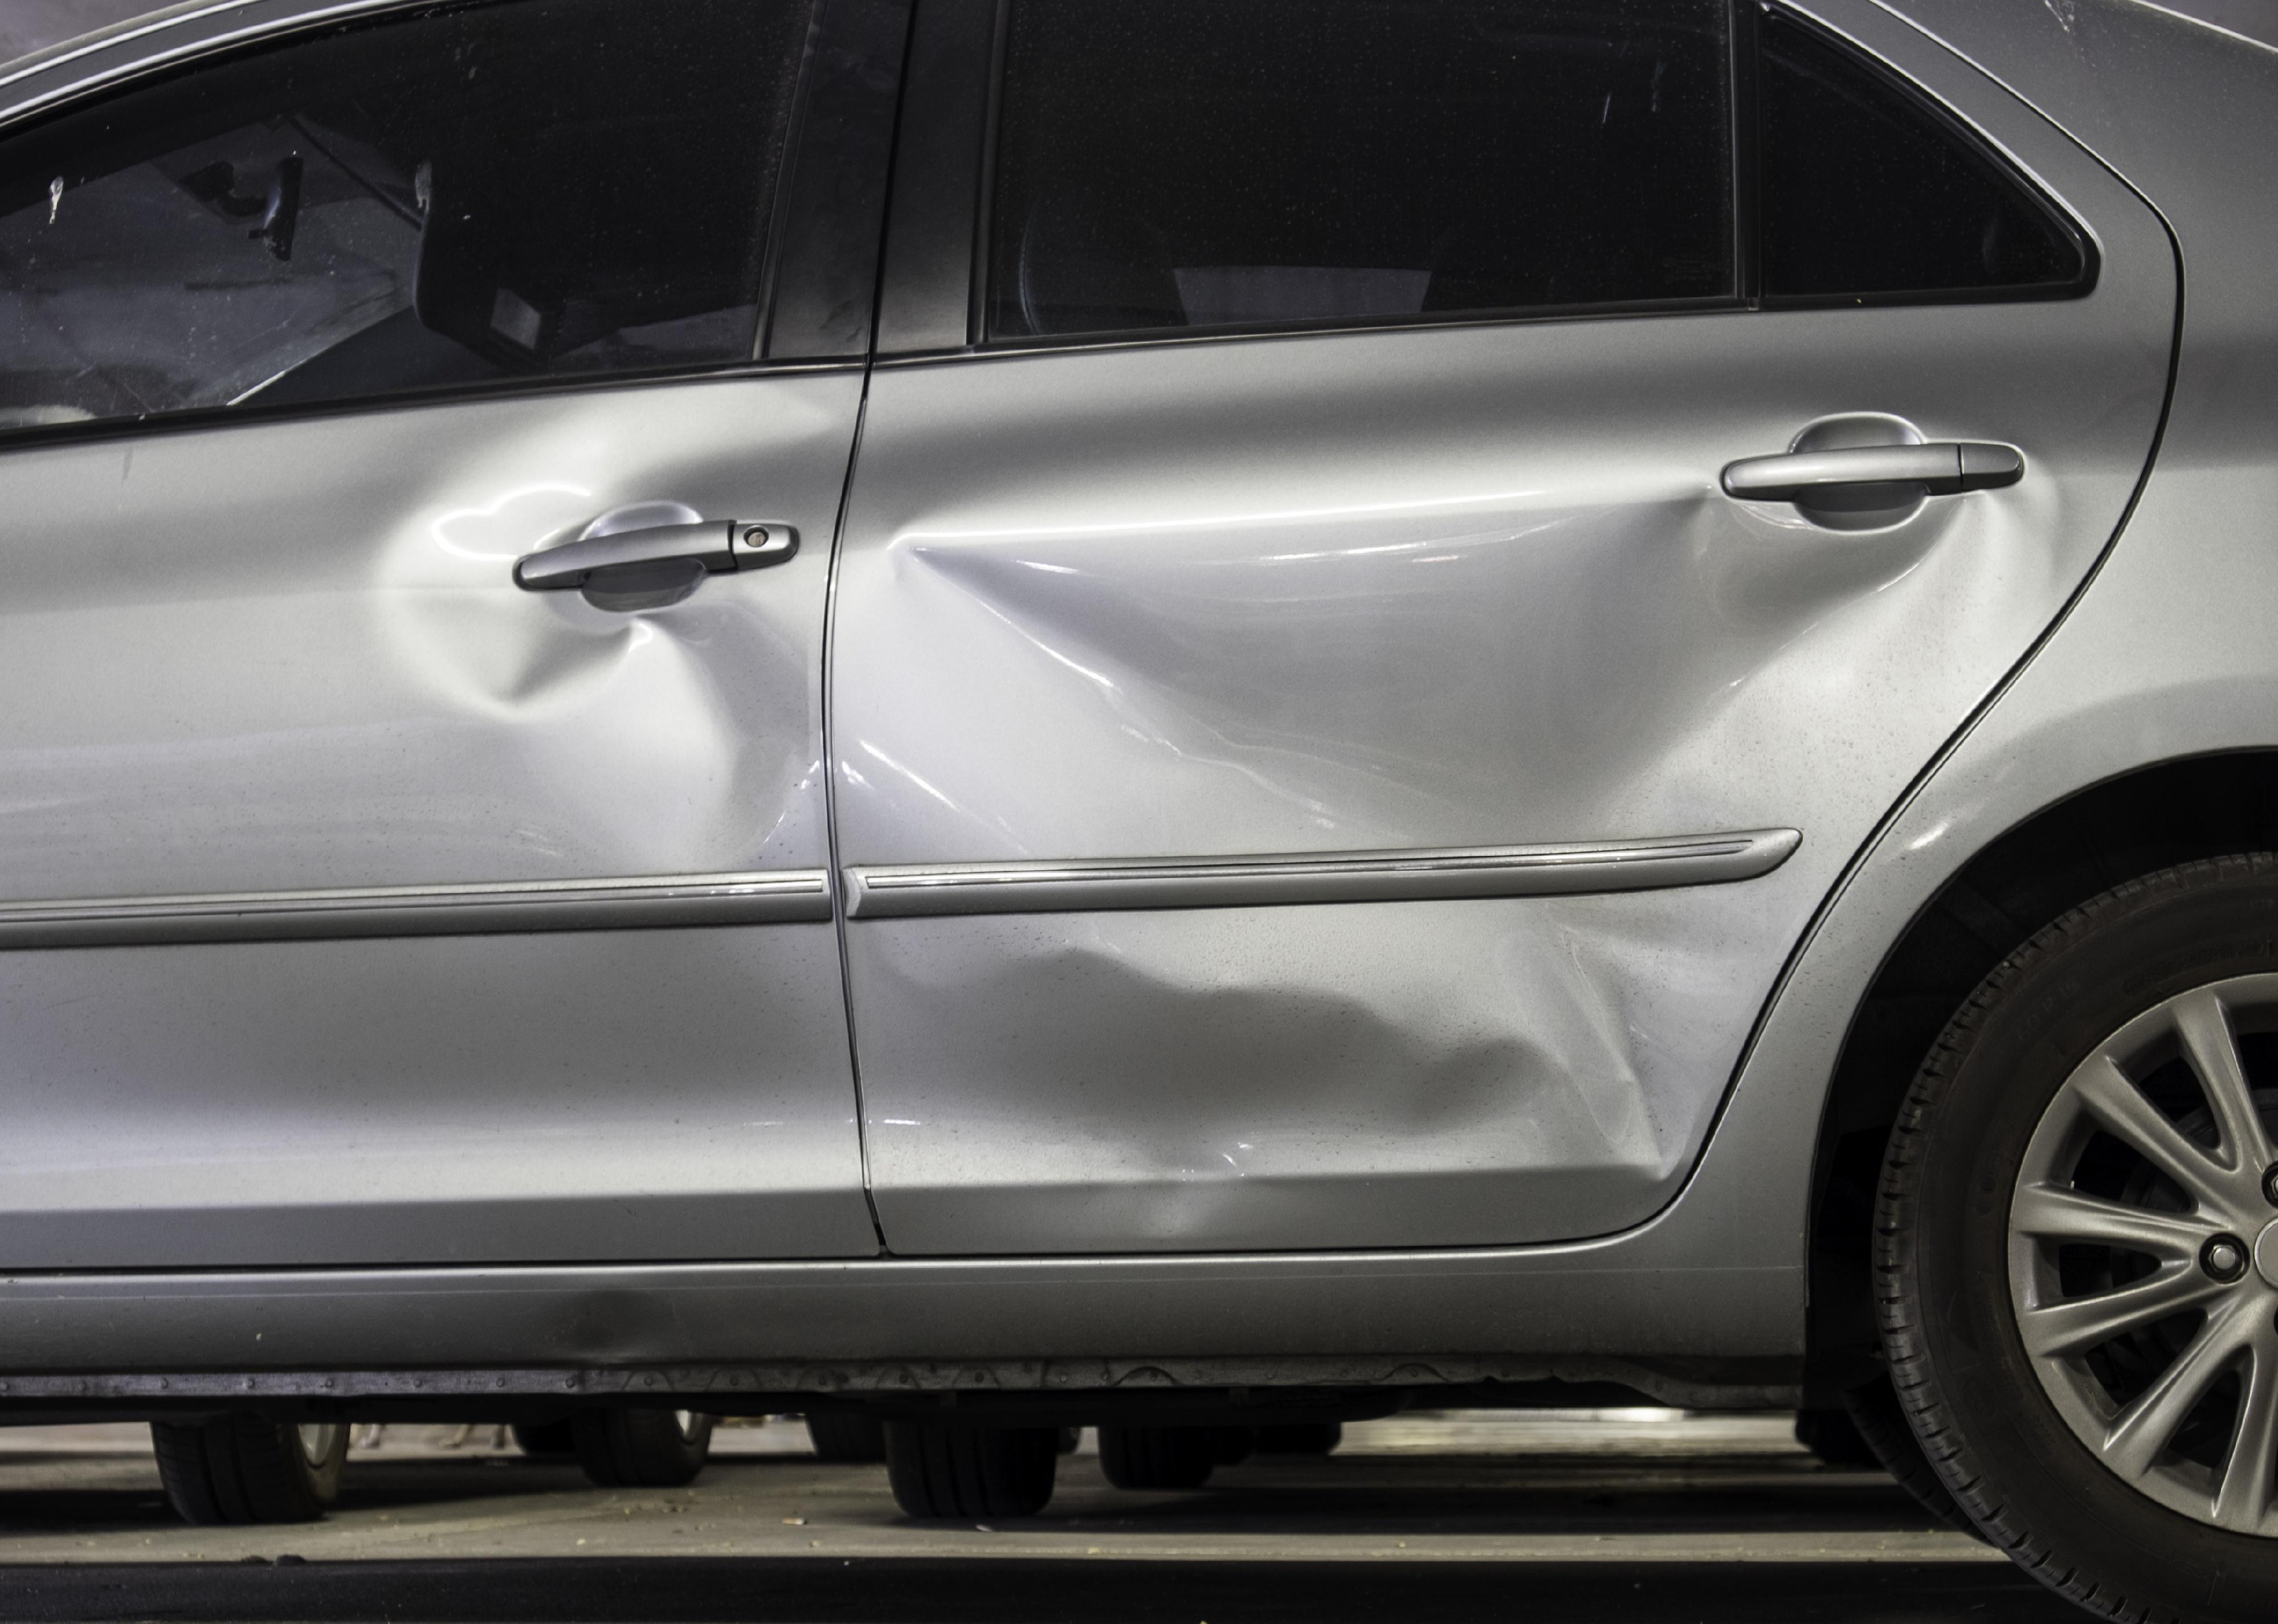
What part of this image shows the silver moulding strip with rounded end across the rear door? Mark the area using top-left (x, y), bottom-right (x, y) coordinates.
top-left (847, 829), bottom-right (1804, 918)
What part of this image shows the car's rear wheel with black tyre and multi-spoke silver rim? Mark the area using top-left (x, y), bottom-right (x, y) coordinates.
top-left (1875, 854), bottom-right (2278, 1624)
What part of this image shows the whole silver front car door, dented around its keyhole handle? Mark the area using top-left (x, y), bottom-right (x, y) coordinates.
top-left (0, 0), bottom-right (900, 1268)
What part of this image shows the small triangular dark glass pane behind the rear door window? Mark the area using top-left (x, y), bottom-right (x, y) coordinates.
top-left (1758, 14), bottom-right (2082, 301)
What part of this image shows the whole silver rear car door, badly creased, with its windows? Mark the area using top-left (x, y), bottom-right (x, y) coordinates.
top-left (831, 0), bottom-right (2178, 1252)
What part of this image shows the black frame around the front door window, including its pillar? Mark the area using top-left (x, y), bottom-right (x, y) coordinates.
top-left (0, 0), bottom-right (913, 453)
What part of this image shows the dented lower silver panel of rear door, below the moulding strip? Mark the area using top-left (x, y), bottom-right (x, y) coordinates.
top-left (847, 882), bottom-right (1781, 1255)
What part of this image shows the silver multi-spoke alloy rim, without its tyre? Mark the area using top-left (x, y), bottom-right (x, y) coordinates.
top-left (2009, 975), bottom-right (2278, 1537)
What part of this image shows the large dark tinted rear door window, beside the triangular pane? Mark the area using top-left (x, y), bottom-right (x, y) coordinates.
top-left (989, 0), bottom-right (1733, 337)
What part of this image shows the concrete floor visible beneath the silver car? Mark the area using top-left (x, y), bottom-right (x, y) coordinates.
top-left (0, 1412), bottom-right (2080, 1624)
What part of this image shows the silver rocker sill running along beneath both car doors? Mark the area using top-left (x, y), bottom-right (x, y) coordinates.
top-left (0, 1246), bottom-right (1799, 1385)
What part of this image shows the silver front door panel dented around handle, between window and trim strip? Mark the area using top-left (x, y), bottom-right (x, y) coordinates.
top-left (0, 374), bottom-right (861, 900)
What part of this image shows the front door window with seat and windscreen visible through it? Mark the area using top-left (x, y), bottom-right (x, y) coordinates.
top-left (0, 0), bottom-right (806, 426)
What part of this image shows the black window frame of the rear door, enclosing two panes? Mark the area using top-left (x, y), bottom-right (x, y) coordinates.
top-left (877, 0), bottom-right (2100, 360)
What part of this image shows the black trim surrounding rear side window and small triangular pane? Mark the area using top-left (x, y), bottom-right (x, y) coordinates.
top-left (877, 0), bottom-right (2103, 365)
